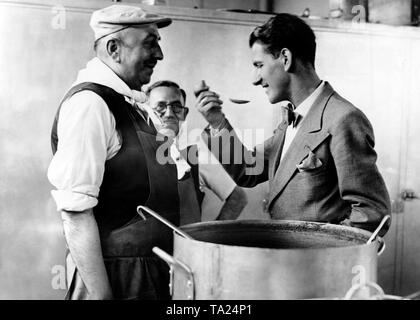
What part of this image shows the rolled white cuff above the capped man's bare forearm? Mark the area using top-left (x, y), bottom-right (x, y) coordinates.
top-left (51, 190), bottom-right (98, 212)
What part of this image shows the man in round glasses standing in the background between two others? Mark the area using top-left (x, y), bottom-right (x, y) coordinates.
top-left (146, 80), bottom-right (247, 225)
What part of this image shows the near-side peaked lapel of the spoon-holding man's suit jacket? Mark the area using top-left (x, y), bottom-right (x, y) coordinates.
top-left (269, 82), bottom-right (334, 206)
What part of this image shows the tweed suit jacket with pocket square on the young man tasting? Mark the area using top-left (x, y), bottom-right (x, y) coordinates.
top-left (203, 82), bottom-right (390, 234)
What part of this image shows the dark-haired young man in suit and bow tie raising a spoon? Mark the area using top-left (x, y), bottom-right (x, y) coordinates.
top-left (196, 14), bottom-right (390, 234)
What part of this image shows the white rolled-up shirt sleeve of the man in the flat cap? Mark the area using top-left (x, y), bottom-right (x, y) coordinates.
top-left (48, 91), bottom-right (119, 211)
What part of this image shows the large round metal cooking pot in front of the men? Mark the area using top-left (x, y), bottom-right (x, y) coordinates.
top-left (139, 206), bottom-right (385, 300)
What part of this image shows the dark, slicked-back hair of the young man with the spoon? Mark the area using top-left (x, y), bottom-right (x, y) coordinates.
top-left (249, 13), bottom-right (316, 67)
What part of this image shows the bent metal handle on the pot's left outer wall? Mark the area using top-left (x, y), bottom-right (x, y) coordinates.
top-left (152, 247), bottom-right (194, 300)
